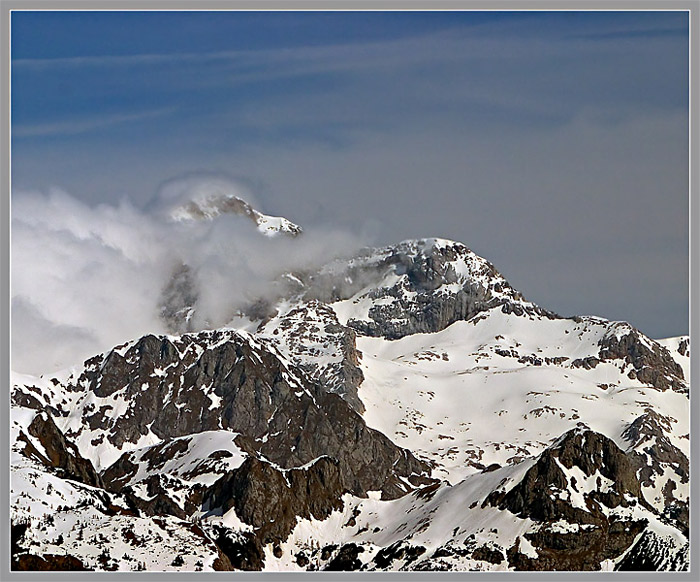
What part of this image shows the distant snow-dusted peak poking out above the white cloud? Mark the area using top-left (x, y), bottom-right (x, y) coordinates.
top-left (170, 194), bottom-right (302, 236)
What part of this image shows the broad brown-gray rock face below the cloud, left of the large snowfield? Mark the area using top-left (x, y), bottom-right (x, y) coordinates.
top-left (69, 331), bottom-right (430, 498)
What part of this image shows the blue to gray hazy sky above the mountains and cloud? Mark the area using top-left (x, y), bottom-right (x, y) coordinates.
top-left (12, 11), bottom-right (688, 336)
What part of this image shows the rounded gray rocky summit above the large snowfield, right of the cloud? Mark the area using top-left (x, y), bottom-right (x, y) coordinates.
top-left (304, 239), bottom-right (554, 339)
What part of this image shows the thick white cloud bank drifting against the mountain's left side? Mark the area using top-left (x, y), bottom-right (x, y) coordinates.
top-left (11, 176), bottom-right (370, 374)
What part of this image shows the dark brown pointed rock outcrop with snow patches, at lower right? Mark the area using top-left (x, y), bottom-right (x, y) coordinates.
top-left (484, 429), bottom-right (653, 570)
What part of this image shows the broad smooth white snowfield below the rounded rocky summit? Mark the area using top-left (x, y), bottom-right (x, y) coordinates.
top-left (357, 318), bottom-right (689, 482)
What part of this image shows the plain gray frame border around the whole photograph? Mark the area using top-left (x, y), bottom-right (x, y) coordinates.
top-left (0, 0), bottom-right (700, 581)
